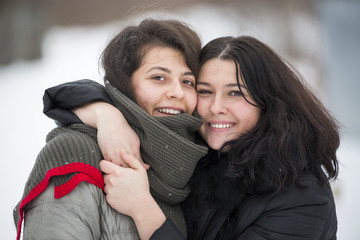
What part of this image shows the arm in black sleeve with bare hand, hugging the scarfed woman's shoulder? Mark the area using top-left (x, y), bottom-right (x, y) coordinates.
top-left (43, 79), bottom-right (149, 168)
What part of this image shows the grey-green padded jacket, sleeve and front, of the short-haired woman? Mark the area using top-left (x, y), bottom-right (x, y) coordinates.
top-left (24, 181), bottom-right (139, 239)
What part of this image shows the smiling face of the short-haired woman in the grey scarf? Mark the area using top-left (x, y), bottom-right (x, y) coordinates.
top-left (131, 46), bottom-right (197, 117)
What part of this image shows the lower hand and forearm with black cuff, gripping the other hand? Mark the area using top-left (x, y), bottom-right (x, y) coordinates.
top-left (100, 151), bottom-right (185, 240)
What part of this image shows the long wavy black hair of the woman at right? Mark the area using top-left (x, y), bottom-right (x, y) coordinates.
top-left (200, 36), bottom-right (340, 193)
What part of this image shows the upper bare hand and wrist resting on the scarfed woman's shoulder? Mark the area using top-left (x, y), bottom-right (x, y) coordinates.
top-left (73, 102), bottom-right (150, 169)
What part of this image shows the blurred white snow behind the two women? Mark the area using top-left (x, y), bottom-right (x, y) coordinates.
top-left (0, 2), bottom-right (360, 240)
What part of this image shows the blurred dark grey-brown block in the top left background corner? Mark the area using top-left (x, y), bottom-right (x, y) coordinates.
top-left (0, 0), bottom-right (49, 65)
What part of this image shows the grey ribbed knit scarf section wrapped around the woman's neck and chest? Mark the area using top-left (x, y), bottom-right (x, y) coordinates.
top-left (105, 81), bottom-right (208, 233)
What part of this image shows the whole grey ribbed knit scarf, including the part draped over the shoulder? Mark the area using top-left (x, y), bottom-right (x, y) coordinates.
top-left (14, 82), bottom-right (207, 234)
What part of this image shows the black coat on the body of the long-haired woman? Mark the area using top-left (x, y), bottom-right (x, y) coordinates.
top-left (151, 153), bottom-right (337, 240)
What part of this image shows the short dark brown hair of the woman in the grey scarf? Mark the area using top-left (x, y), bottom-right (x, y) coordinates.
top-left (101, 18), bottom-right (201, 101)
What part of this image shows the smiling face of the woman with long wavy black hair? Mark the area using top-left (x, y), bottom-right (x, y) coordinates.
top-left (197, 58), bottom-right (260, 150)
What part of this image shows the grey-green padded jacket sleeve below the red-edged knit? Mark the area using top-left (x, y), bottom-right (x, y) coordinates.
top-left (23, 182), bottom-right (101, 240)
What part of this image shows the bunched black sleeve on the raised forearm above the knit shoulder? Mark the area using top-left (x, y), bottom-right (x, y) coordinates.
top-left (43, 79), bottom-right (112, 126)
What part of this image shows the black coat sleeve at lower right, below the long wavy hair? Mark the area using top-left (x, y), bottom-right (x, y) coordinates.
top-left (237, 176), bottom-right (337, 240)
